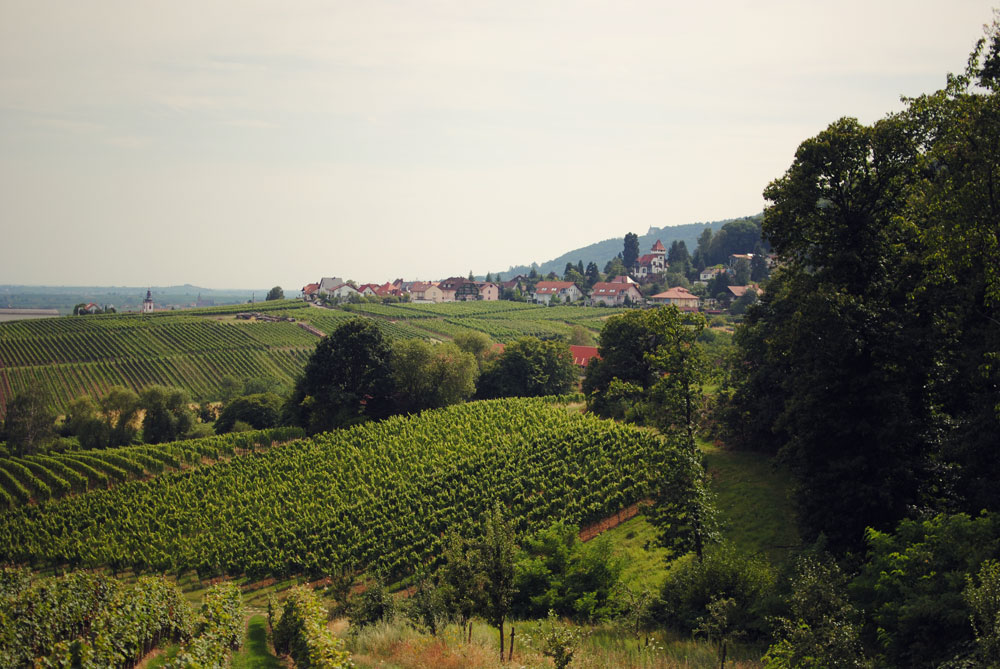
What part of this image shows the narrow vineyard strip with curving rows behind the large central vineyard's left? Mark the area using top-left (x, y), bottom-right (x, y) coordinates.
top-left (0, 427), bottom-right (305, 509)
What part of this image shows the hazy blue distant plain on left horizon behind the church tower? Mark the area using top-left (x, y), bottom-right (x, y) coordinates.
top-left (0, 283), bottom-right (268, 315)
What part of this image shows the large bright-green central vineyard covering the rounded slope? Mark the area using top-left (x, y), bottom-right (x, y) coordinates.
top-left (0, 399), bottom-right (679, 578)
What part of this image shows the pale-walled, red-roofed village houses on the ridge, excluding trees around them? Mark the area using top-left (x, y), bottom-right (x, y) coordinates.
top-left (302, 240), bottom-right (759, 310)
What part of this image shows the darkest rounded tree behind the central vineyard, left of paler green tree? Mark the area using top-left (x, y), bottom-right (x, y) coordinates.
top-left (284, 318), bottom-right (393, 433)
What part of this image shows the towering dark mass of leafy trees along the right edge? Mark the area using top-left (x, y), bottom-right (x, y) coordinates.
top-left (727, 24), bottom-right (1000, 552)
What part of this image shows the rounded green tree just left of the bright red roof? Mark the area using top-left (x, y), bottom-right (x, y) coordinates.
top-left (477, 337), bottom-right (576, 398)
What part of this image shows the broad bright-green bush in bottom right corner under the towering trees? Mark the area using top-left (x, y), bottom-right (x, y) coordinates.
top-left (851, 514), bottom-right (1000, 669)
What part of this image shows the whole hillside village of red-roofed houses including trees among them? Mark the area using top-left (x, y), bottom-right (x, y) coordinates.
top-left (301, 240), bottom-right (774, 314)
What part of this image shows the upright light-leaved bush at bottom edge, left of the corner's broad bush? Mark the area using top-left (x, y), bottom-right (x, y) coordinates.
top-left (764, 555), bottom-right (868, 669)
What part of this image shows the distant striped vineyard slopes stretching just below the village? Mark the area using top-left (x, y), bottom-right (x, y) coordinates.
top-left (0, 300), bottom-right (621, 418)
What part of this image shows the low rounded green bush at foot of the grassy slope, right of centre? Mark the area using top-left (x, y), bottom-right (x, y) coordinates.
top-left (655, 545), bottom-right (775, 639)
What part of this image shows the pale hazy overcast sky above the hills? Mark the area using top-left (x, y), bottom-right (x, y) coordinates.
top-left (0, 0), bottom-right (995, 293)
